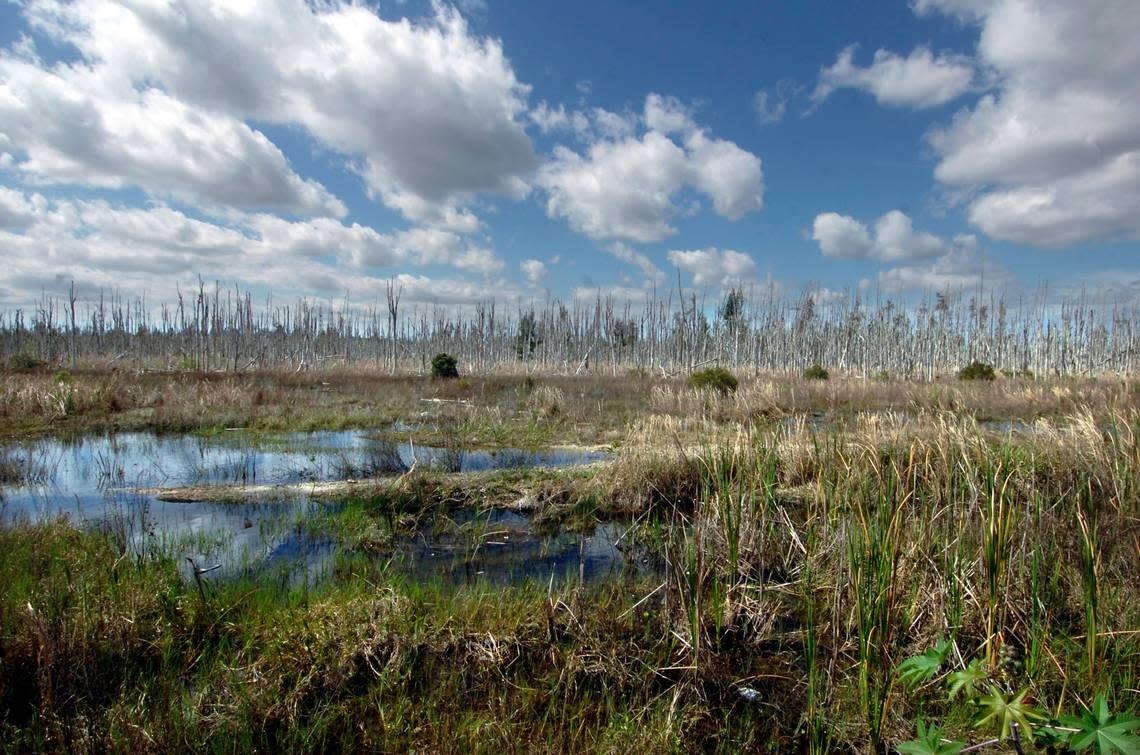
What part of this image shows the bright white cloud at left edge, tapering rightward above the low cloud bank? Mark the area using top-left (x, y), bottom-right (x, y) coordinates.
top-left (0, 54), bottom-right (345, 217)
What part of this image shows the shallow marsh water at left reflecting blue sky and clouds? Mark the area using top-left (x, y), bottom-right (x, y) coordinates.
top-left (0, 431), bottom-right (621, 583)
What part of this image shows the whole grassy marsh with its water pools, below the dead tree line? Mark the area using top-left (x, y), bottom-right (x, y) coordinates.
top-left (0, 368), bottom-right (1140, 753)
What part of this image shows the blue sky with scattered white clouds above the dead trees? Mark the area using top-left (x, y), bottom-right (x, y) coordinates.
top-left (0, 0), bottom-right (1140, 309)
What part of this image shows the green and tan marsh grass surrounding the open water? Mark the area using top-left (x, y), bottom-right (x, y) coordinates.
top-left (0, 373), bottom-right (1140, 753)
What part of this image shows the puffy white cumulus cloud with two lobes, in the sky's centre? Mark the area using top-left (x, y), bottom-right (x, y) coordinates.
top-left (537, 95), bottom-right (764, 243)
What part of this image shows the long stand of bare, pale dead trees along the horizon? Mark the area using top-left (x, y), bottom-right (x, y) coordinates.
top-left (0, 282), bottom-right (1140, 379)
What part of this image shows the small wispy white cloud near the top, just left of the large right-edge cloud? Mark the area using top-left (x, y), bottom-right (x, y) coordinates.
top-left (812, 44), bottom-right (974, 107)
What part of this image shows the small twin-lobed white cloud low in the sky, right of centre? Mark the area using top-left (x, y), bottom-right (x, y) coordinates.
top-left (812, 210), bottom-right (950, 261)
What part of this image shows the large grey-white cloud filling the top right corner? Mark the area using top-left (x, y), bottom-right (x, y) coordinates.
top-left (915, 0), bottom-right (1140, 247)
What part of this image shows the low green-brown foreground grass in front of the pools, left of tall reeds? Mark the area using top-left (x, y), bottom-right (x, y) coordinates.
top-left (0, 522), bottom-right (795, 752)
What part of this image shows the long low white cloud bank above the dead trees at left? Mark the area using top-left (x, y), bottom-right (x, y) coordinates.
top-left (0, 187), bottom-right (513, 303)
